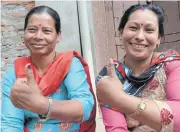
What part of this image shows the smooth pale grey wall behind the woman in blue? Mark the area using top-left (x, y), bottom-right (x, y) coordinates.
top-left (35, 0), bottom-right (81, 54)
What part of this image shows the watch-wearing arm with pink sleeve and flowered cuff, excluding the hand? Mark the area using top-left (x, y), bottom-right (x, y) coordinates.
top-left (108, 61), bottom-right (180, 132)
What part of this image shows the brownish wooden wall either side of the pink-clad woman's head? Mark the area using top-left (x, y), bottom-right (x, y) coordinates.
top-left (92, 0), bottom-right (180, 74)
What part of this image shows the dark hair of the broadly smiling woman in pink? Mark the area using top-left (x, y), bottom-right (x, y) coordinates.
top-left (118, 4), bottom-right (164, 37)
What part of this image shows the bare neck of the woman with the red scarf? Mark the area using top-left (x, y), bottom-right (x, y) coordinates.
top-left (31, 52), bottom-right (56, 75)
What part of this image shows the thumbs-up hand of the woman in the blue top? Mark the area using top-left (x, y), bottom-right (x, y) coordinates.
top-left (10, 64), bottom-right (48, 114)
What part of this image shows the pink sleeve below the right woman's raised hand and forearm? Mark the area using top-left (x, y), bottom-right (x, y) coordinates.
top-left (100, 106), bottom-right (128, 132)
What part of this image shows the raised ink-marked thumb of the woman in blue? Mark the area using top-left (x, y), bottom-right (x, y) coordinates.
top-left (25, 63), bottom-right (35, 85)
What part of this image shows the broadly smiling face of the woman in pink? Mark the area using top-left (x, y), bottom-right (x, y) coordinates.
top-left (122, 9), bottom-right (160, 60)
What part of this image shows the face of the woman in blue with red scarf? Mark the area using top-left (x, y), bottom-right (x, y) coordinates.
top-left (24, 13), bottom-right (60, 55)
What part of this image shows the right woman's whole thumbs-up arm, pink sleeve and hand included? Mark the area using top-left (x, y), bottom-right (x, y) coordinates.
top-left (97, 61), bottom-right (180, 132)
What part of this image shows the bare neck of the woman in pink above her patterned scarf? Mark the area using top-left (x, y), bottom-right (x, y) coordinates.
top-left (124, 54), bottom-right (153, 76)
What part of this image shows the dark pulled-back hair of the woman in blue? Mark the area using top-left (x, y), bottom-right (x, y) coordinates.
top-left (24, 6), bottom-right (61, 33)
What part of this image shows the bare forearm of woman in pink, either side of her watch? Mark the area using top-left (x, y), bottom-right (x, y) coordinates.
top-left (113, 94), bottom-right (161, 131)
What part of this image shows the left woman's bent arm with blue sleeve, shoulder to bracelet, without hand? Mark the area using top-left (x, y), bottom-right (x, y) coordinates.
top-left (43, 57), bottom-right (94, 123)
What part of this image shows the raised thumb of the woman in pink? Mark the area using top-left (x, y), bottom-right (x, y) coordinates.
top-left (107, 58), bottom-right (117, 78)
